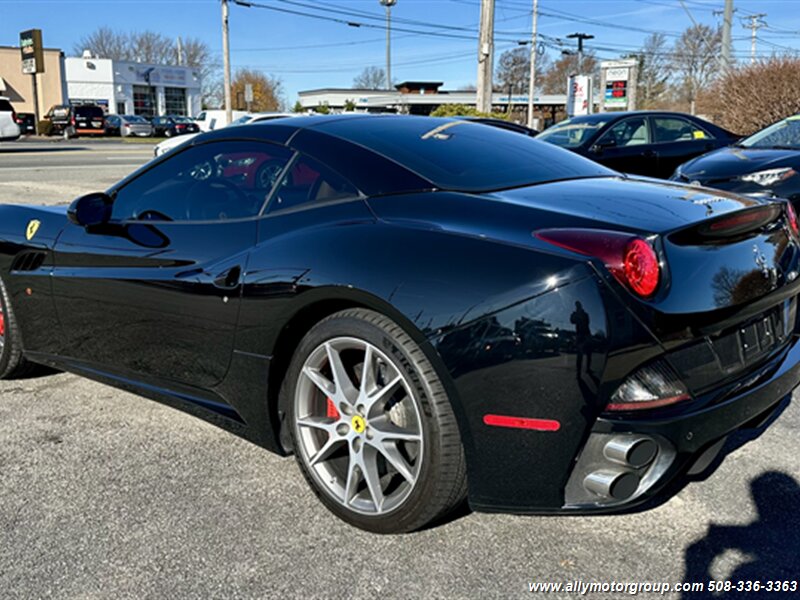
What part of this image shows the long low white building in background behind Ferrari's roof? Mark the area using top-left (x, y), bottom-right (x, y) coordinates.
top-left (298, 81), bottom-right (567, 126)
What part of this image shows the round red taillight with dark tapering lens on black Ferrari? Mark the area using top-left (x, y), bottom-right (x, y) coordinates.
top-left (534, 229), bottom-right (661, 298)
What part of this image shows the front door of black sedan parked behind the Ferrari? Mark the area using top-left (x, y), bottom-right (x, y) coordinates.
top-left (589, 116), bottom-right (658, 175)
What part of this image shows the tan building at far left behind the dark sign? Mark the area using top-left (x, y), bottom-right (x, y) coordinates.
top-left (0, 46), bottom-right (67, 115)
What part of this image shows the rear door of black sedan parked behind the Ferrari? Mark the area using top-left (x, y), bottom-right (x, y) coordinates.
top-left (651, 115), bottom-right (717, 179)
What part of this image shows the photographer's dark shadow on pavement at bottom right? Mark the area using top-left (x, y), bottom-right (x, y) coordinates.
top-left (682, 471), bottom-right (800, 598)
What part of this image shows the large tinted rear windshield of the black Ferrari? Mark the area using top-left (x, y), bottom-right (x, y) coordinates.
top-left (319, 116), bottom-right (617, 192)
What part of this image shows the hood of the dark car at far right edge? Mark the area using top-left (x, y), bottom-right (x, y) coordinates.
top-left (679, 146), bottom-right (800, 182)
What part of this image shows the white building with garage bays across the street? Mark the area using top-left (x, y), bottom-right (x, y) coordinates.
top-left (64, 57), bottom-right (202, 116)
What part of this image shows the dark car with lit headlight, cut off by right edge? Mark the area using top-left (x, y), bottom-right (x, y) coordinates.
top-left (672, 115), bottom-right (800, 207)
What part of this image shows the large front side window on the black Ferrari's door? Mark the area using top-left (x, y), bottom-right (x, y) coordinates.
top-left (112, 142), bottom-right (292, 221)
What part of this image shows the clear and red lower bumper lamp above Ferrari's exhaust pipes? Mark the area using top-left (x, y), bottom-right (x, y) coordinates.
top-left (606, 361), bottom-right (690, 411)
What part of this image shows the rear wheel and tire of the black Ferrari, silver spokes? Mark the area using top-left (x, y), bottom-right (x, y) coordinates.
top-left (281, 309), bottom-right (466, 533)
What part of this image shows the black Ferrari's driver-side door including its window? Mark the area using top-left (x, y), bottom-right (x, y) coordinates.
top-left (53, 141), bottom-right (290, 388)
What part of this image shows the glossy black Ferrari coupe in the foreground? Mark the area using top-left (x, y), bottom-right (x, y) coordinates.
top-left (0, 115), bottom-right (800, 532)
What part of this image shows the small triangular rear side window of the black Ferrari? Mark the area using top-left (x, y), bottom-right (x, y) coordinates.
top-left (267, 155), bottom-right (359, 213)
